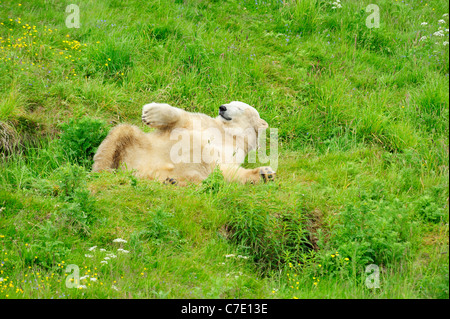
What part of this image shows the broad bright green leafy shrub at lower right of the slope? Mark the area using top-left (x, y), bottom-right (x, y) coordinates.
top-left (321, 193), bottom-right (416, 270)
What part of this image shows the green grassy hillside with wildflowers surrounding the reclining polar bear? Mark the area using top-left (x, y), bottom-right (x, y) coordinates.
top-left (0, 0), bottom-right (449, 298)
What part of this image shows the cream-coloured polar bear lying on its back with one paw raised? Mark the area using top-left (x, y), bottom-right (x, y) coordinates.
top-left (92, 101), bottom-right (275, 185)
